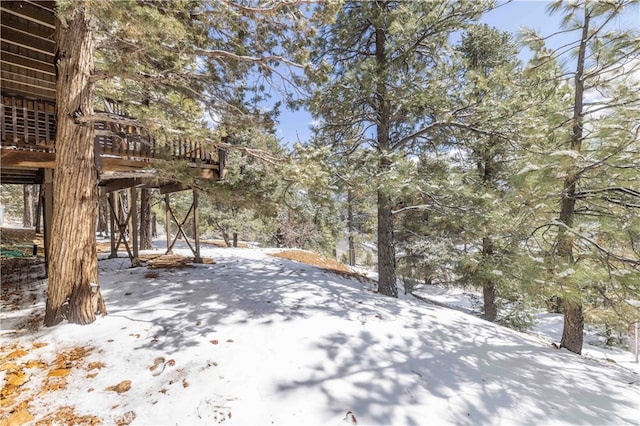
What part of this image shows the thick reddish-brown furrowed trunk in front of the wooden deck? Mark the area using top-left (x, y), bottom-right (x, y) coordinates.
top-left (44, 1), bottom-right (106, 326)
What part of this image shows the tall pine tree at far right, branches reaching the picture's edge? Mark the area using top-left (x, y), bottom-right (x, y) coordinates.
top-left (527, 0), bottom-right (640, 353)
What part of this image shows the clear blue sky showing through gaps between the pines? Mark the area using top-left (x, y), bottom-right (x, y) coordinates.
top-left (278, 0), bottom-right (640, 146)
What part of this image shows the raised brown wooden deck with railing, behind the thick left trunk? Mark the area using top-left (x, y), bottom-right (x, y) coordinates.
top-left (0, 94), bottom-right (226, 183)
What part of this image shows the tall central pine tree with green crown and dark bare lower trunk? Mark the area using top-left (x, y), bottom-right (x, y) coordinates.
top-left (309, 1), bottom-right (488, 297)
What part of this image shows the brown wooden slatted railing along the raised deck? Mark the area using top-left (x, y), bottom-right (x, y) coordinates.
top-left (0, 94), bottom-right (226, 172)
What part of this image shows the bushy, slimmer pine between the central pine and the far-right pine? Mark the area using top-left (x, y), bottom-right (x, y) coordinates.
top-left (450, 24), bottom-right (530, 321)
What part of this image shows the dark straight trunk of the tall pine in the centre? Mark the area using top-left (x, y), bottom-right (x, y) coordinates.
top-left (375, 1), bottom-right (398, 297)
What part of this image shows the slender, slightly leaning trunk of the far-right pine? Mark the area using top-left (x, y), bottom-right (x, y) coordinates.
top-left (557, 3), bottom-right (590, 354)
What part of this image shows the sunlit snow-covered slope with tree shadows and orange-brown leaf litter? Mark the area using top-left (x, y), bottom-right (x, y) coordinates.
top-left (0, 248), bottom-right (640, 425)
